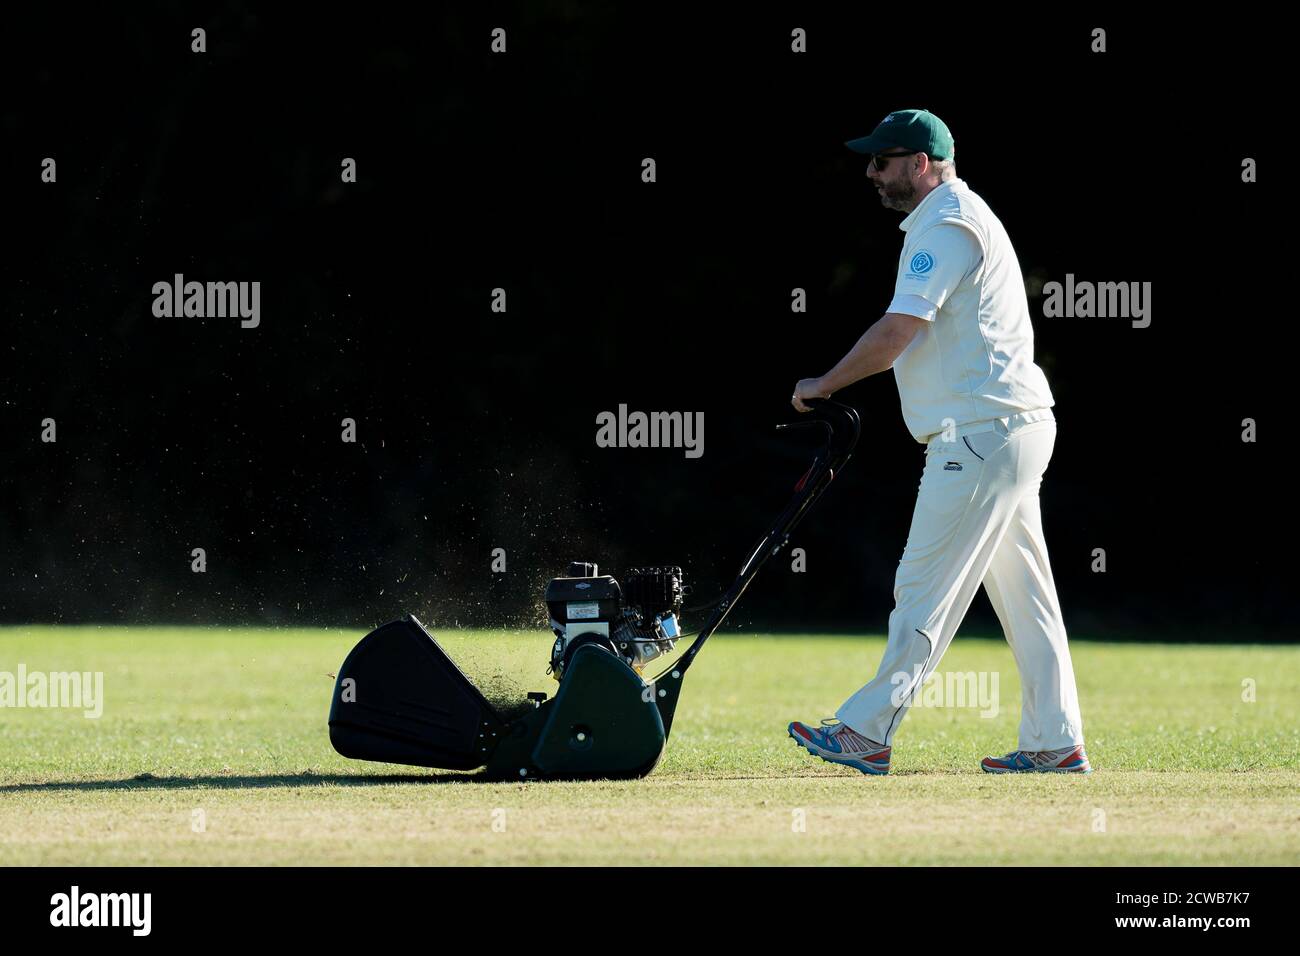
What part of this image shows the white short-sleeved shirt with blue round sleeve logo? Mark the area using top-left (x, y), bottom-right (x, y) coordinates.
top-left (888, 179), bottom-right (1054, 444)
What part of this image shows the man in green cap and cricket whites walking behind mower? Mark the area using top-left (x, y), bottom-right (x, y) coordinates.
top-left (789, 109), bottom-right (1091, 774)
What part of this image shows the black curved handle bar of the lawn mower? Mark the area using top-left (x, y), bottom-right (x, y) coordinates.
top-left (655, 398), bottom-right (862, 682)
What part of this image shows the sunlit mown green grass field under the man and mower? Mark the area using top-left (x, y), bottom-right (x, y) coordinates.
top-left (0, 627), bottom-right (1300, 866)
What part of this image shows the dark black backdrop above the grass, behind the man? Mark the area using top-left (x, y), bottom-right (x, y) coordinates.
top-left (0, 3), bottom-right (1294, 641)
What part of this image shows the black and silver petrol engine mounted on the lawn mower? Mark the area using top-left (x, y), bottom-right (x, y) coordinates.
top-left (546, 561), bottom-right (686, 680)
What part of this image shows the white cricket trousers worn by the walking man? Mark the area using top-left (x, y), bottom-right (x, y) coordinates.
top-left (836, 408), bottom-right (1083, 750)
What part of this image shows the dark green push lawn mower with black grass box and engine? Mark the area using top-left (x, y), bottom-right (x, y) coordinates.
top-left (329, 399), bottom-right (859, 779)
